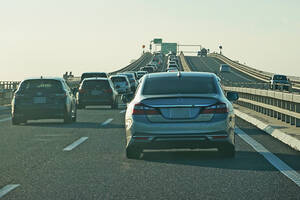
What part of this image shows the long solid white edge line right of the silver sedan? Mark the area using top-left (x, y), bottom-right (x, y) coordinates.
top-left (235, 128), bottom-right (300, 187)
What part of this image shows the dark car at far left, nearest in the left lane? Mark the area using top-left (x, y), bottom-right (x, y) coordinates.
top-left (11, 77), bottom-right (77, 125)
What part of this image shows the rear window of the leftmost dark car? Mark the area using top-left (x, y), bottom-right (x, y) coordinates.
top-left (19, 79), bottom-right (63, 93)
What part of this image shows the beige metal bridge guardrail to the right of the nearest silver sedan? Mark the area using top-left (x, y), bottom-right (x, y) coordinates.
top-left (223, 86), bottom-right (300, 127)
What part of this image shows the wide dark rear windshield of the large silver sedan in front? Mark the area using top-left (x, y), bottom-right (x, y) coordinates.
top-left (142, 77), bottom-right (217, 95)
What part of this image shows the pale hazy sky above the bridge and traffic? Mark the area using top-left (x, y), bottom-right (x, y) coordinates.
top-left (0, 0), bottom-right (300, 81)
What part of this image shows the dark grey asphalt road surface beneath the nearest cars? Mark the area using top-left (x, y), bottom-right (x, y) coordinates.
top-left (0, 104), bottom-right (300, 199)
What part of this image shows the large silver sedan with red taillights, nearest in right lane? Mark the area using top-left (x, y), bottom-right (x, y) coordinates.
top-left (124, 72), bottom-right (238, 158)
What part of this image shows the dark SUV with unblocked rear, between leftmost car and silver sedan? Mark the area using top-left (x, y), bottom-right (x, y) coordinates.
top-left (77, 78), bottom-right (118, 109)
